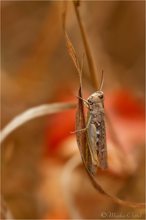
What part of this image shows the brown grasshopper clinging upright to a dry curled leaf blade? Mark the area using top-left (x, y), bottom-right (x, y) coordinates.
top-left (75, 74), bottom-right (108, 169)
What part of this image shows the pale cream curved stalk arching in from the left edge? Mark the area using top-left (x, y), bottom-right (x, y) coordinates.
top-left (0, 103), bottom-right (76, 143)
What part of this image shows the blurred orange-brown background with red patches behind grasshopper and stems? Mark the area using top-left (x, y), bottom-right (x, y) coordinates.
top-left (1, 1), bottom-right (145, 219)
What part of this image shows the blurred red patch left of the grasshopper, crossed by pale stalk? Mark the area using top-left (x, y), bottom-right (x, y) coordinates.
top-left (45, 90), bottom-right (77, 154)
